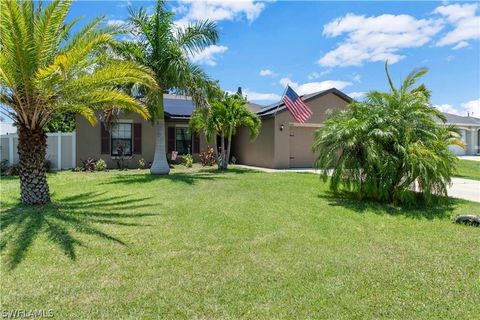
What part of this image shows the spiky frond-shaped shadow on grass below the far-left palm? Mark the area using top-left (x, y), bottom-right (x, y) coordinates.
top-left (0, 192), bottom-right (160, 270)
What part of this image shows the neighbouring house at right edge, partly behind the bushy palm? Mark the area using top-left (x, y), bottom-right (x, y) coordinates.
top-left (443, 112), bottom-right (480, 156)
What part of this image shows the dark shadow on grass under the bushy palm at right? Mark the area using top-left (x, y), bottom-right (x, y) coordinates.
top-left (318, 192), bottom-right (462, 220)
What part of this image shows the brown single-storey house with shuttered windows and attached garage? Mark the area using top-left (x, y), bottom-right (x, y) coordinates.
top-left (76, 89), bottom-right (351, 168)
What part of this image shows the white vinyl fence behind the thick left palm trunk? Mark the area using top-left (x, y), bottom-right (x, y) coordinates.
top-left (0, 131), bottom-right (76, 170)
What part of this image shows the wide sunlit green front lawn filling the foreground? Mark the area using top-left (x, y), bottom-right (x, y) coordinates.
top-left (0, 169), bottom-right (480, 319)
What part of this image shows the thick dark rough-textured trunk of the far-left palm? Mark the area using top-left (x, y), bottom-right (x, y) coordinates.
top-left (18, 125), bottom-right (50, 205)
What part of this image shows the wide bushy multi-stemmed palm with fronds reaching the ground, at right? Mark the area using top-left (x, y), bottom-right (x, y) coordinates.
top-left (312, 64), bottom-right (463, 203)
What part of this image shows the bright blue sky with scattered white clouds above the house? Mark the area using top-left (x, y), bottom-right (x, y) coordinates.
top-left (70, 1), bottom-right (480, 117)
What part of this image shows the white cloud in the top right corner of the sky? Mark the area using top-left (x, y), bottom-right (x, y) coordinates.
top-left (433, 3), bottom-right (480, 50)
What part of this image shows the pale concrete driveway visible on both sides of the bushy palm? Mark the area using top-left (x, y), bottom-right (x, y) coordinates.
top-left (235, 164), bottom-right (480, 202)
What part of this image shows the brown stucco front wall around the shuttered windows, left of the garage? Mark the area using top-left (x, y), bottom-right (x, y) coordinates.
top-left (76, 114), bottom-right (207, 168)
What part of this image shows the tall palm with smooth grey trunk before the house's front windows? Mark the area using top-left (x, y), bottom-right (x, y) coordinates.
top-left (117, 1), bottom-right (218, 174)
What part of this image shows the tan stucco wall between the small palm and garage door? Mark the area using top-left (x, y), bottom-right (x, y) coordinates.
top-left (232, 119), bottom-right (275, 168)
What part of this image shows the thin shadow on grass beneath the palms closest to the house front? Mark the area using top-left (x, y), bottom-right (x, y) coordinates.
top-left (100, 168), bottom-right (253, 185)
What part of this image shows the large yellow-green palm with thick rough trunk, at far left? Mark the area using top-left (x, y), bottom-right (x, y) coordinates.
top-left (0, 0), bottom-right (155, 204)
